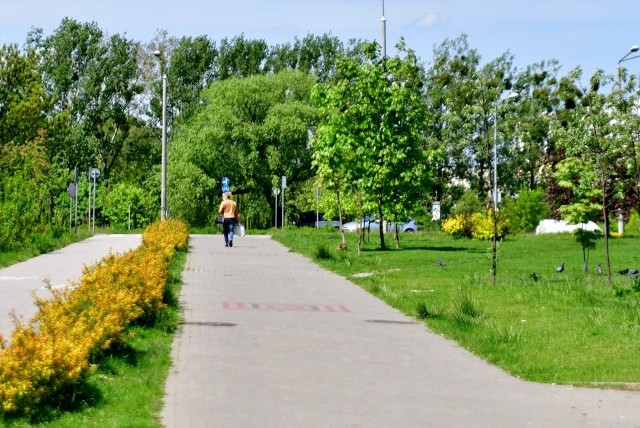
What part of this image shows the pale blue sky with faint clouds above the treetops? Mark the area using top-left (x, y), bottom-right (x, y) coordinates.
top-left (0, 0), bottom-right (640, 76)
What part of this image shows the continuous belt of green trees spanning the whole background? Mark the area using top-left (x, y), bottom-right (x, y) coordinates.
top-left (0, 18), bottom-right (640, 258)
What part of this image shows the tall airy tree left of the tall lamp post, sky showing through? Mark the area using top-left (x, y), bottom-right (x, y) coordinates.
top-left (29, 18), bottom-right (142, 177)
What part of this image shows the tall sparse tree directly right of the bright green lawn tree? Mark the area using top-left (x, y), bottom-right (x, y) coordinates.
top-left (425, 35), bottom-right (516, 203)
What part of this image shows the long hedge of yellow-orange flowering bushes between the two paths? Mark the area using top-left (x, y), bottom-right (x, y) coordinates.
top-left (0, 220), bottom-right (189, 414)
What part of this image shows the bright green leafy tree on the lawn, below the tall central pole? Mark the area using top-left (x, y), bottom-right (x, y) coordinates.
top-left (312, 43), bottom-right (431, 249)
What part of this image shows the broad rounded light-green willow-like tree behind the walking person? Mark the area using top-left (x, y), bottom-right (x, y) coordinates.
top-left (168, 72), bottom-right (316, 227)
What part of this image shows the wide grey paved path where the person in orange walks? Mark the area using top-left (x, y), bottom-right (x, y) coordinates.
top-left (161, 235), bottom-right (640, 428)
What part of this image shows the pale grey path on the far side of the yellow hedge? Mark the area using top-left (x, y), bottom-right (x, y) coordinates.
top-left (0, 234), bottom-right (142, 339)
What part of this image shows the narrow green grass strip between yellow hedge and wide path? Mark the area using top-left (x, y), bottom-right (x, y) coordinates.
top-left (0, 251), bottom-right (186, 428)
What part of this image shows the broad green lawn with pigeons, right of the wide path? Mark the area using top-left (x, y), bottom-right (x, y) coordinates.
top-left (274, 229), bottom-right (640, 388)
